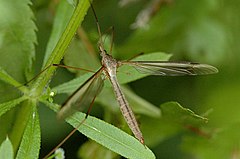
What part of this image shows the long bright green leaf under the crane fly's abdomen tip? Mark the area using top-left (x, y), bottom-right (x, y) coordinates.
top-left (42, 101), bottom-right (155, 159)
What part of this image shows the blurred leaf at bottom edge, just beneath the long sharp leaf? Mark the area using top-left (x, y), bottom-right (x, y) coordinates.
top-left (78, 141), bottom-right (119, 159)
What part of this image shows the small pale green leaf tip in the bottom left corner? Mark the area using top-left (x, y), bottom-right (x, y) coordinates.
top-left (0, 137), bottom-right (14, 159)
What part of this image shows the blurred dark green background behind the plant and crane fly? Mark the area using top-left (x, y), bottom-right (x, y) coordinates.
top-left (0, 0), bottom-right (240, 159)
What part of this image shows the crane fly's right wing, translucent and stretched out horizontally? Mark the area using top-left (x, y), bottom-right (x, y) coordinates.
top-left (121, 61), bottom-right (218, 76)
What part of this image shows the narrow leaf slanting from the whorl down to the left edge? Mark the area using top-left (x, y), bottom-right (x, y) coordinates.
top-left (0, 96), bottom-right (26, 116)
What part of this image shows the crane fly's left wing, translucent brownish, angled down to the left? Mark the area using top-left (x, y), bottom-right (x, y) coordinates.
top-left (57, 67), bottom-right (103, 119)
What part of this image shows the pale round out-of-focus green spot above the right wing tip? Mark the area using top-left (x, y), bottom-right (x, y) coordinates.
top-left (185, 19), bottom-right (227, 63)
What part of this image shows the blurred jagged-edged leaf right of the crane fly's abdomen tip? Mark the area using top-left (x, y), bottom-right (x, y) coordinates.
top-left (141, 102), bottom-right (207, 146)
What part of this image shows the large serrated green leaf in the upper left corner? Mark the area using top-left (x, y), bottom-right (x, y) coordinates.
top-left (0, 0), bottom-right (37, 83)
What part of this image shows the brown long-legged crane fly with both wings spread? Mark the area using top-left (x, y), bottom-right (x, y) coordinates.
top-left (43, 0), bottom-right (218, 158)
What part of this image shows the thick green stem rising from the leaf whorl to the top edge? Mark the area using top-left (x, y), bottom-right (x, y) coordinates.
top-left (30, 0), bottom-right (90, 97)
